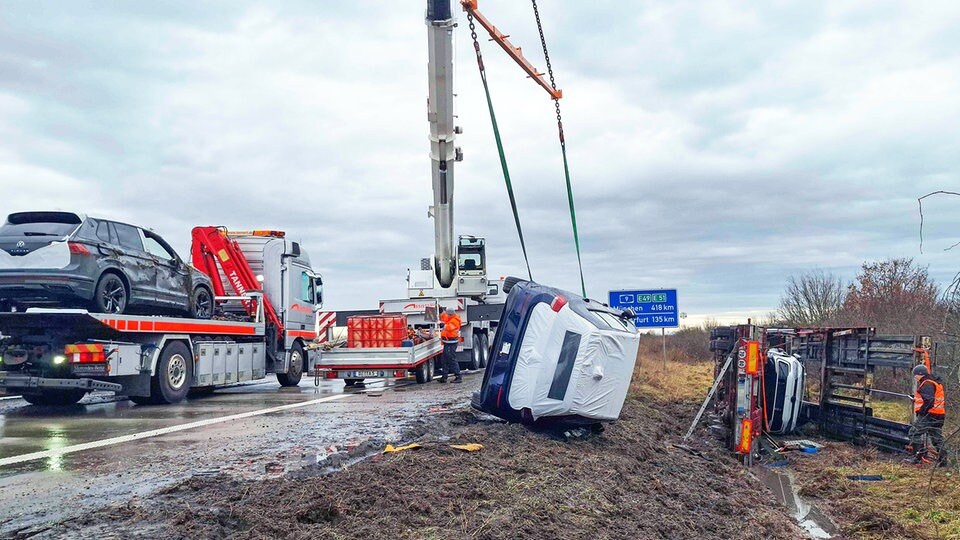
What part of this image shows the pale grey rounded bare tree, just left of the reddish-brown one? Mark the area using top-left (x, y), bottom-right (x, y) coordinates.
top-left (777, 270), bottom-right (846, 327)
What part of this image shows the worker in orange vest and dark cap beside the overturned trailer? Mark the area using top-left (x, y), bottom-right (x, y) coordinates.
top-left (910, 364), bottom-right (947, 466)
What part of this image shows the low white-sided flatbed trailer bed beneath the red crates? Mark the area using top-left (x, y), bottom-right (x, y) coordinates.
top-left (311, 337), bottom-right (443, 384)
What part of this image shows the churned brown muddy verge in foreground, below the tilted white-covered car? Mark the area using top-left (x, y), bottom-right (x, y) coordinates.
top-left (50, 378), bottom-right (803, 539)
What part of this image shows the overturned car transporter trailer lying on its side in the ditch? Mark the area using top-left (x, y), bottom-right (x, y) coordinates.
top-left (710, 325), bottom-right (932, 451)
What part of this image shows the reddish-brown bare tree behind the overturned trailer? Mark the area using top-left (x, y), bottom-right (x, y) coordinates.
top-left (840, 258), bottom-right (945, 334)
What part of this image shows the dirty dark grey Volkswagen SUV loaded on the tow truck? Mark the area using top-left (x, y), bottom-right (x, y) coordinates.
top-left (0, 212), bottom-right (214, 319)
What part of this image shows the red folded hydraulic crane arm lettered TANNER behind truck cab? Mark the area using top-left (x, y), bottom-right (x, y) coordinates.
top-left (190, 227), bottom-right (283, 336)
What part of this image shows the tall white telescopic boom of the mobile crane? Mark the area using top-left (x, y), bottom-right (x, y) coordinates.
top-left (426, 0), bottom-right (462, 287)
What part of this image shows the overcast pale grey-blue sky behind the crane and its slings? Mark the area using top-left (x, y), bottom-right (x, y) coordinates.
top-left (0, 0), bottom-right (960, 322)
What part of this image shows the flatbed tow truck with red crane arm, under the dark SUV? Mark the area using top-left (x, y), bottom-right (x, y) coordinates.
top-left (0, 227), bottom-right (323, 405)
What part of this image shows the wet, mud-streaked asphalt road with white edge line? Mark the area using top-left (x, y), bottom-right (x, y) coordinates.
top-left (0, 373), bottom-right (481, 537)
